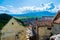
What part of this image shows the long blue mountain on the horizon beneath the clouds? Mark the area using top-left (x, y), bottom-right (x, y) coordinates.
top-left (10, 11), bottom-right (56, 17)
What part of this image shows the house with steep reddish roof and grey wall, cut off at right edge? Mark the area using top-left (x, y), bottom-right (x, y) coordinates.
top-left (53, 11), bottom-right (60, 34)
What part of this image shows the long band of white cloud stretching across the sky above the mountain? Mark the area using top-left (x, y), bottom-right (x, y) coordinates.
top-left (0, 2), bottom-right (60, 14)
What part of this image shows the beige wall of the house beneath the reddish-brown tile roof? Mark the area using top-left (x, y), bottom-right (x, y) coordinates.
top-left (39, 27), bottom-right (52, 40)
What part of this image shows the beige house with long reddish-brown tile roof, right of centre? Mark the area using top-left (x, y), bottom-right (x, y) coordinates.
top-left (35, 16), bottom-right (53, 40)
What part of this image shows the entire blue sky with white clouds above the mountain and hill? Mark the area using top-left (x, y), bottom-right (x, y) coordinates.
top-left (0, 0), bottom-right (60, 14)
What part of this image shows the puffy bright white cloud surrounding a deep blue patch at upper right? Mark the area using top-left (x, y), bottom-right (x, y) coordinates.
top-left (43, 2), bottom-right (60, 13)
